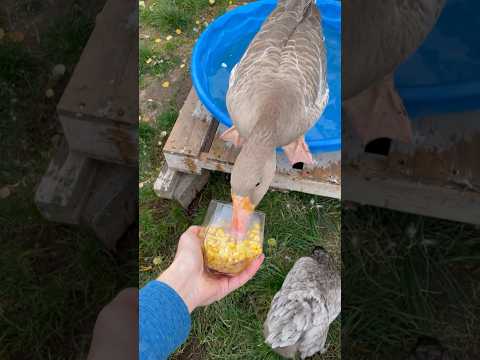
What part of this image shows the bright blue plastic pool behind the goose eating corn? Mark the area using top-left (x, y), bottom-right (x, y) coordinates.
top-left (192, 0), bottom-right (341, 152)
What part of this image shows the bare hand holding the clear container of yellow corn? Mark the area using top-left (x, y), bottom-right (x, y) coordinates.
top-left (157, 226), bottom-right (265, 312)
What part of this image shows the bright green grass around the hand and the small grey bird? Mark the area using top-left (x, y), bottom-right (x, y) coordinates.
top-left (140, 174), bottom-right (340, 359)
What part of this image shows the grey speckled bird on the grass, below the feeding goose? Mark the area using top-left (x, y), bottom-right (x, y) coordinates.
top-left (264, 248), bottom-right (341, 359)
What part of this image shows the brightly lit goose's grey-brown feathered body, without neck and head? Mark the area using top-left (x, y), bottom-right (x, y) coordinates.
top-left (227, 0), bottom-right (328, 150)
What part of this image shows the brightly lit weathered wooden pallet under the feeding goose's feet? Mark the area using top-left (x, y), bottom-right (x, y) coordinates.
top-left (154, 89), bottom-right (340, 206)
